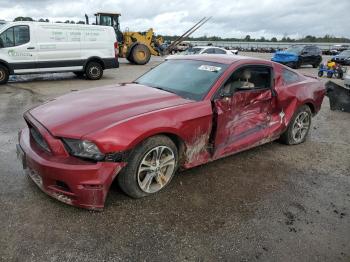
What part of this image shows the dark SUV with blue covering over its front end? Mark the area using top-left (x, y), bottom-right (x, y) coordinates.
top-left (271, 45), bottom-right (322, 69)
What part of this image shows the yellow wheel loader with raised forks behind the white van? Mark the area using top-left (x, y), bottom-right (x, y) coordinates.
top-left (85, 13), bottom-right (210, 65)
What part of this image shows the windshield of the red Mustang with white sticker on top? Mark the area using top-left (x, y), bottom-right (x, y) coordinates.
top-left (135, 60), bottom-right (228, 101)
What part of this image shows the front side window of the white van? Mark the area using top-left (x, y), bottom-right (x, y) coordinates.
top-left (0, 25), bottom-right (30, 48)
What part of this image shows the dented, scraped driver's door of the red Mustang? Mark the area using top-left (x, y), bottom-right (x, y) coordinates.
top-left (213, 65), bottom-right (273, 158)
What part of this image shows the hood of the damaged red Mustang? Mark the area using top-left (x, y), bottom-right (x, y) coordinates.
top-left (29, 84), bottom-right (193, 138)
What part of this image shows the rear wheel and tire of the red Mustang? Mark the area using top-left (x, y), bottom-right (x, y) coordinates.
top-left (279, 105), bottom-right (312, 145)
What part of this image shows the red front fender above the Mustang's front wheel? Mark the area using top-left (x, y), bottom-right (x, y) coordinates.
top-left (83, 101), bottom-right (212, 153)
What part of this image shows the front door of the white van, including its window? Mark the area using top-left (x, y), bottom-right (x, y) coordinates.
top-left (0, 25), bottom-right (37, 73)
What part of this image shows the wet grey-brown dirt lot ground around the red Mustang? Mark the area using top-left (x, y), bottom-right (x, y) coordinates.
top-left (0, 54), bottom-right (350, 261)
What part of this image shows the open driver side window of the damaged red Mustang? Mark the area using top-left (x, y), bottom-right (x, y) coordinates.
top-left (223, 66), bottom-right (272, 95)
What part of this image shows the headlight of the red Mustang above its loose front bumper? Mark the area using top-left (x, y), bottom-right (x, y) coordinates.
top-left (62, 138), bottom-right (105, 161)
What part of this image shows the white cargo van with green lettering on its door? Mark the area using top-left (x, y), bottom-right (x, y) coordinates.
top-left (0, 22), bottom-right (119, 84)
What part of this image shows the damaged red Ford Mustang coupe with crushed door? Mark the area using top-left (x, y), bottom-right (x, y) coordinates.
top-left (17, 55), bottom-right (325, 209)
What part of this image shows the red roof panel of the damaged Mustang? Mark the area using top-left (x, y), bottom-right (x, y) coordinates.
top-left (167, 54), bottom-right (271, 65)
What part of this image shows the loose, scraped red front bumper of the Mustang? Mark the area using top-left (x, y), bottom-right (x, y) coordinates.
top-left (17, 128), bottom-right (125, 210)
